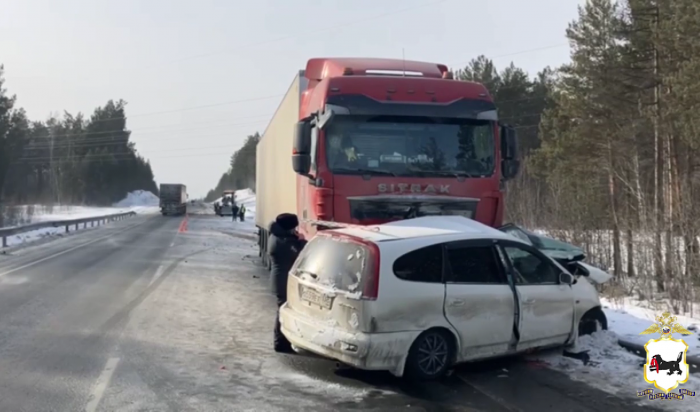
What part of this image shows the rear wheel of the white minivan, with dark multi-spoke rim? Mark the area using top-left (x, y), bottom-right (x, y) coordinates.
top-left (404, 329), bottom-right (455, 381)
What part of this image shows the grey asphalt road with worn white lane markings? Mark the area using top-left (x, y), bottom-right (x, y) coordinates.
top-left (0, 209), bottom-right (651, 412)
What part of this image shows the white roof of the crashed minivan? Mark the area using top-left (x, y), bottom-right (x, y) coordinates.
top-left (326, 216), bottom-right (519, 243)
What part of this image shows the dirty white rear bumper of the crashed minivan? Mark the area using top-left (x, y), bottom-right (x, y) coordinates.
top-left (280, 304), bottom-right (420, 376)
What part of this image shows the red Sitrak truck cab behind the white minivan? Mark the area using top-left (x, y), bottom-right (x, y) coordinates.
top-left (292, 58), bottom-right (519, 237)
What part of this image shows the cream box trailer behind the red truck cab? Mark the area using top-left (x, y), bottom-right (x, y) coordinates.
top-left (255, 70), bottom-right (308, 267)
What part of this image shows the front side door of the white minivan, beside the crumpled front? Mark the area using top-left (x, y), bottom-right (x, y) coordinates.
top-left (499, 241), bottom-right (575, 351)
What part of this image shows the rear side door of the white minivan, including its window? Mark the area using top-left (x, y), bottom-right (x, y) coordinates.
top-left (445, 240), bottom-right (516, 360)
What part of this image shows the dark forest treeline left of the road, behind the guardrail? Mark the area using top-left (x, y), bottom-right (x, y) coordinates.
top-left (0, 66), bottom-right (158, 226)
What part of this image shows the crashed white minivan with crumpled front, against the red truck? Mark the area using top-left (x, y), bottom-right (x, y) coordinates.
top-left (280, 216), bottom-right (609, 379)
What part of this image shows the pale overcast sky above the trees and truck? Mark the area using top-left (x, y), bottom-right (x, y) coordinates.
top-left (0, 0), bottom-right (584, 197)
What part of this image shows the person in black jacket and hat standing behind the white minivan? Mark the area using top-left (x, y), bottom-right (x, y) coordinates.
top-left (268, 213), bottom-right (306, 352)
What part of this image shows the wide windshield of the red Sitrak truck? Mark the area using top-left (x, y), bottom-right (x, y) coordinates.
top-left (325, 116), bottom-right (495, 177)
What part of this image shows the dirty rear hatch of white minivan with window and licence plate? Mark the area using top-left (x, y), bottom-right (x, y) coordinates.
top-left (287, 231), bottom-right (379, 332)
